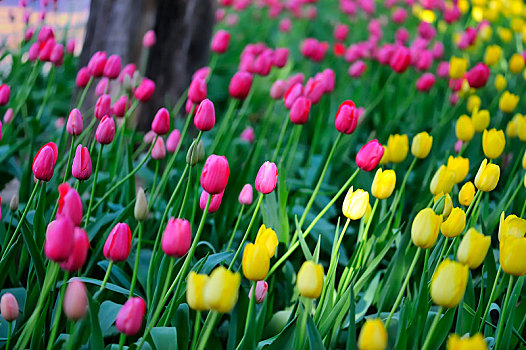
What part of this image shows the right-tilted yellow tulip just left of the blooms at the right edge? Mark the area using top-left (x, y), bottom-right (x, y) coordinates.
top-left (457, 228), bottom-right (491, 269)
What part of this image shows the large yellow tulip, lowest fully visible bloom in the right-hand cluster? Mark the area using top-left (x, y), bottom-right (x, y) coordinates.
top-left (429, 259), bottom-right (469, 308)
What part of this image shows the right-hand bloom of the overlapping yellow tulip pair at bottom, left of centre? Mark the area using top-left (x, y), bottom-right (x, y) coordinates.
top-left (203, 266), bottom-right (241, 314)
